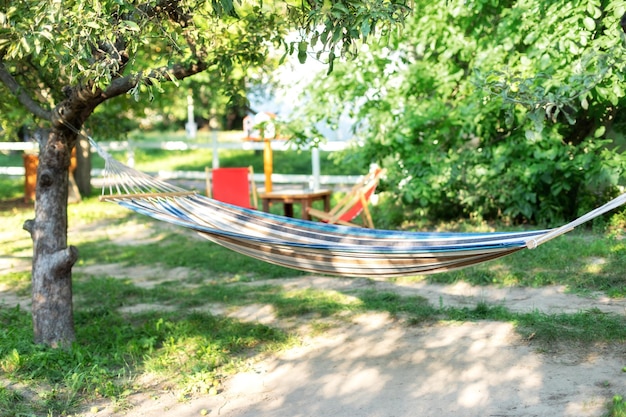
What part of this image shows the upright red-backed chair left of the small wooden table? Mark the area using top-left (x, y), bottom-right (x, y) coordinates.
top-left (205, 166), bottom-right (258, 209)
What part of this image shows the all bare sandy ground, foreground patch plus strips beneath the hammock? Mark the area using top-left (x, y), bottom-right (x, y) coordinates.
top-left (0, 221), bottom-right (626, 417)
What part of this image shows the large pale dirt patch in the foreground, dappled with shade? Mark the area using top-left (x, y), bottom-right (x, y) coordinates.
top-left (105, 314), bottom-right (626, 417)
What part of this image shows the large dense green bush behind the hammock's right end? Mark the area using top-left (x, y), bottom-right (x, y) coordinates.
top-left (290, 0), bottom-right (626, 224)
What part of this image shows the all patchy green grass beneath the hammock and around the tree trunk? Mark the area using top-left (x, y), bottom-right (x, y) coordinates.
top-left (0, 174), bottom-right (626, 417)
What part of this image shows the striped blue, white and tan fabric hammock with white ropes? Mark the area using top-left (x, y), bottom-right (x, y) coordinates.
top-left (90, 138), bottom-right (626, 277)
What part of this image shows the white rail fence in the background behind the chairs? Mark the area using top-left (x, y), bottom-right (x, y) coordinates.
top-left (0, 141), bottom-right (361, 189)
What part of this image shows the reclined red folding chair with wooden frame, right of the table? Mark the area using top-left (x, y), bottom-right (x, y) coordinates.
top-left (307, 168), bottom-right (385, 229)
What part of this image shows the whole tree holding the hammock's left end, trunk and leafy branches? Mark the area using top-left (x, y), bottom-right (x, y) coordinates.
top-left (0, 0), bottom-right (408, 346)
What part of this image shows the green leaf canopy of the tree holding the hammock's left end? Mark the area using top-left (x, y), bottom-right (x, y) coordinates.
top-left (0, 0), bottom-right (408, 136)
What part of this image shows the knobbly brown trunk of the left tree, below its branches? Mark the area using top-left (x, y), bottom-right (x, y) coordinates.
top-left (24, 129), bottom-right (78, 347)
